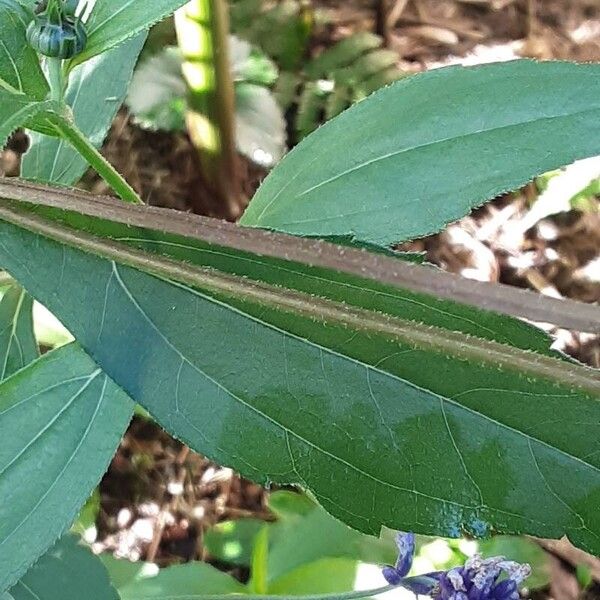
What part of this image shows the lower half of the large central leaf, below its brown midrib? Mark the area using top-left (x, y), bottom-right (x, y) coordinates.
top-left (0, 206), bottom-right (600, 549)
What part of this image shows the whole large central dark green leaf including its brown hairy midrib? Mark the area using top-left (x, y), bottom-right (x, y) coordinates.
top-left (0, 195), bottom-right (600, 552)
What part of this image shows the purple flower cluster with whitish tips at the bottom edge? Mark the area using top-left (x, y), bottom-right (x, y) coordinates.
top-left (382, 533), bottom-right (531, 600)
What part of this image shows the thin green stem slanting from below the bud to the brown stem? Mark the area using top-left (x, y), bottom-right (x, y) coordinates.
top-left (51, 117), bottom-right (143, 204)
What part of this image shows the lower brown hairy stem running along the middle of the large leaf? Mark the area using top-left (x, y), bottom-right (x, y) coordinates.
top-left (0, 201), bottom-right (600, 396)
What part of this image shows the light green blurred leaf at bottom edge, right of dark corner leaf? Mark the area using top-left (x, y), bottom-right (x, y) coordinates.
top-left (119, 562), bottom-right (247, 600)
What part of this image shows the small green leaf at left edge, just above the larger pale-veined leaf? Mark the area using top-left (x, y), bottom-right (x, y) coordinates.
top-left (0, 285), bottom-right (39, 381)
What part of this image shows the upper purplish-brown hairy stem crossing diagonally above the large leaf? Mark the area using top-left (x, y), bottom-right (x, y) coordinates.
top-left (0, 179), bottom-right (600, 333)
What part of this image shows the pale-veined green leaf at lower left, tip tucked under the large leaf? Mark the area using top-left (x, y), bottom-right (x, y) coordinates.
top-left (0, 345), bottom-right (133, 591)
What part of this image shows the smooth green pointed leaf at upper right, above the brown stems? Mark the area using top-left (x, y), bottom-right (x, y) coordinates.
top-left (242, 60), bottom-right (600, 245)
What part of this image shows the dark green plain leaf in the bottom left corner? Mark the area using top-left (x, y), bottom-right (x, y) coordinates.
top-left (10, 535), bottom-right (119, 600)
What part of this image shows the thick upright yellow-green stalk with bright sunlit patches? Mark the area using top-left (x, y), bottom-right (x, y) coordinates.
top-left (175, 0), bottom-right (244, 219)
